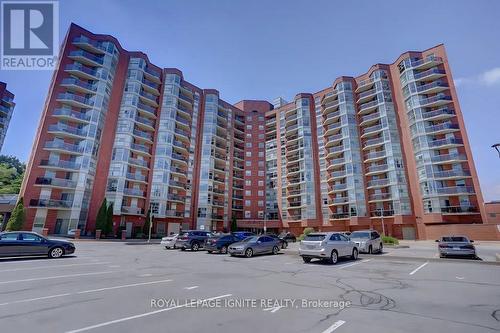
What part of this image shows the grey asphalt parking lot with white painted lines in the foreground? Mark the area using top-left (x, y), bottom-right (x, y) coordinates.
top-left (0, 241), bottom-right (500, 333)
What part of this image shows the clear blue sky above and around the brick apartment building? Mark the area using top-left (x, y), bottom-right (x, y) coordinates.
top-left (0, 0), bottom-right (500, 201)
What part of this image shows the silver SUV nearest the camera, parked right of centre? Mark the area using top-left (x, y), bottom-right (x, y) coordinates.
top-left (299, 232), bottom-right (359, 264)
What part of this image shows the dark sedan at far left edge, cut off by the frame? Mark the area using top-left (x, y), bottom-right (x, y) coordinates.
top-left (0, 231), bottom-right (75, 258)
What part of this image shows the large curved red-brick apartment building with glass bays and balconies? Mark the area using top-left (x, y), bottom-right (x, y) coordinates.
top-left (21, 24), bottom-right (494, 239)
